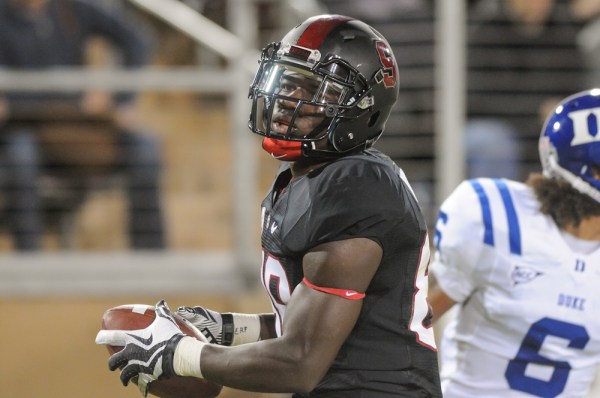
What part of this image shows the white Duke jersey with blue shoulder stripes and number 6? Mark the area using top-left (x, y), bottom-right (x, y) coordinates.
top-left (430, 179), bottom-right (600, 398)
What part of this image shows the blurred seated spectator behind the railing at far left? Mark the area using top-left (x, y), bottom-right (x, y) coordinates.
top-left (0, 0), bottom-right (165, 250)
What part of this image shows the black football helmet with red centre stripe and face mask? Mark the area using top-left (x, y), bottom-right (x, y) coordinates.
top-left (249, 15), bottom-right (398, 160)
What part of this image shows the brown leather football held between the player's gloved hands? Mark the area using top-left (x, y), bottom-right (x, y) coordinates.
top-left (102, 304), bottom-right (223, 398)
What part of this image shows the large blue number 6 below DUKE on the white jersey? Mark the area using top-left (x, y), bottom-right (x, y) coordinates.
top-left (504, 318), bottom-right (590, 398)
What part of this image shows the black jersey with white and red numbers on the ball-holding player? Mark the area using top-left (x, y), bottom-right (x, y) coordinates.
top-left (261, 149), bottom-right (441, 397)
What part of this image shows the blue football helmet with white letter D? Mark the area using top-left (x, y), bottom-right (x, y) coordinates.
top-left (539, 88), bottom-right (600, 203)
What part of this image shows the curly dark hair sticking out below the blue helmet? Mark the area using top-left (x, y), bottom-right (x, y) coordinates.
top-left (527, 173), bottom-right (600, 229)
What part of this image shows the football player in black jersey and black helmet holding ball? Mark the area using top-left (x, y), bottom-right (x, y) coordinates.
top-left (97, 15), bottom-right (441, 398)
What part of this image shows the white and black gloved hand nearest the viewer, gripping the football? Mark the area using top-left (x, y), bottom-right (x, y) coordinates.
top-left (96, 300), bottom-right (184, 397)
